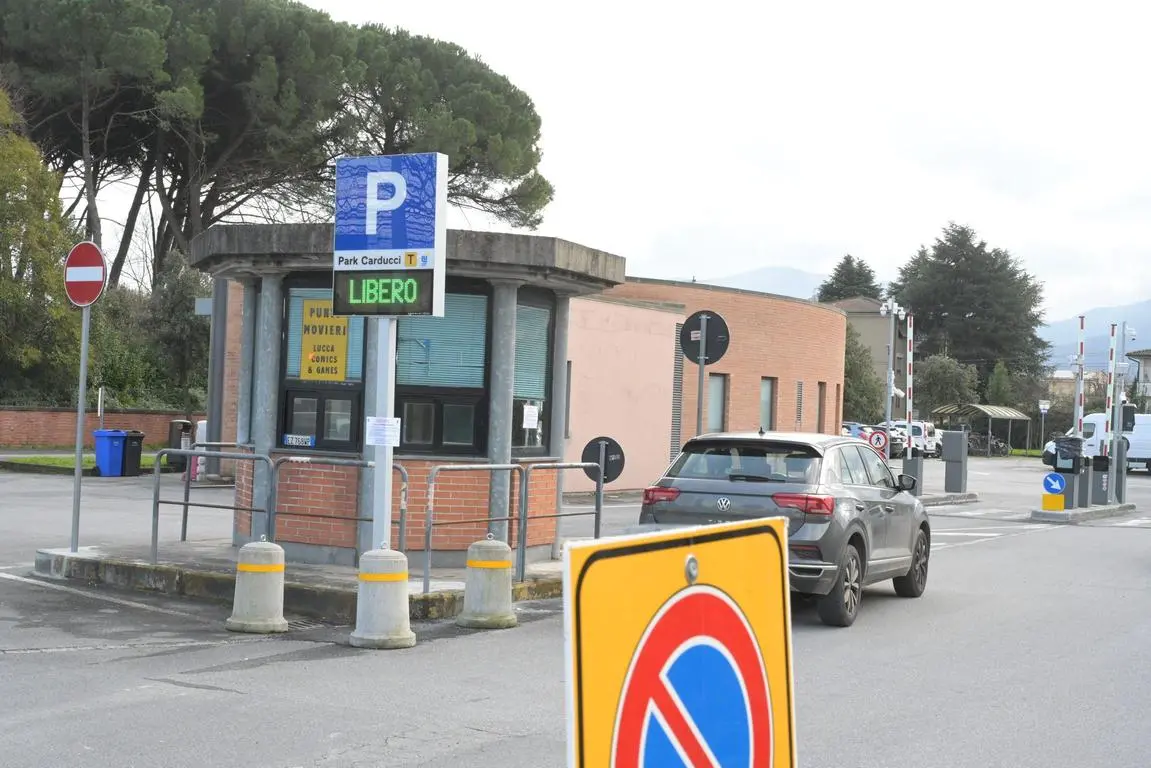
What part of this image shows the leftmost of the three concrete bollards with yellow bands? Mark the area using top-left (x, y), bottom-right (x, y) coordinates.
top-left (223, 540), bottom-right (288, 634)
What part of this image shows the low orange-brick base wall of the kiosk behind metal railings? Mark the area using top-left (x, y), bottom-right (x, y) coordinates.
top-left (235, 458), bottom-right (556, 552)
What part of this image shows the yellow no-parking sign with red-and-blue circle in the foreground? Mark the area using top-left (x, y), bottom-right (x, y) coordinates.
top-left (563, 517), bottom-right (795, 768)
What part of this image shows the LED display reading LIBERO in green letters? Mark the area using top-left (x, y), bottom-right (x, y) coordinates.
top-left (331, 269), bottom-right (435, 315)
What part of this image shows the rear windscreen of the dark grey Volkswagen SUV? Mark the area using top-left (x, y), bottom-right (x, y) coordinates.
top-left (666, 440), bottom-right (821, 484)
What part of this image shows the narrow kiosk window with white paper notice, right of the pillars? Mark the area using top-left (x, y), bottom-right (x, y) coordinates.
top-left (511, 289), bottom-right (552, 454)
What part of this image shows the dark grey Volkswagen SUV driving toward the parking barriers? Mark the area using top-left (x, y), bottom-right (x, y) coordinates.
top-left (639, 432), bottom-right (931, 626)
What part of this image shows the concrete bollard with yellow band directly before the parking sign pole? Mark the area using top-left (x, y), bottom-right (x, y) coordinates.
top-left (351, 549), bottom-right (416, 649)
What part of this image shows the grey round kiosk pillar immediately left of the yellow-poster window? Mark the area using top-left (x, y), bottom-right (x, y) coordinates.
top-left (251, 274), bottom-right (284, 539)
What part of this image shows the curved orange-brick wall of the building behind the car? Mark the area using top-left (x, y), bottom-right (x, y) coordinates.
top-left (607, 277), bottom-right (847, 440)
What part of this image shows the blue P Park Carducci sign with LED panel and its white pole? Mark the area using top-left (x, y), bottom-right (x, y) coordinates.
top-left (331, 152), bottom-right (448, 548)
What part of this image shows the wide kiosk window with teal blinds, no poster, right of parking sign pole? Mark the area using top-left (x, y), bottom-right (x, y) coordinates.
top-left (396, 284), bottom-right (488, 455)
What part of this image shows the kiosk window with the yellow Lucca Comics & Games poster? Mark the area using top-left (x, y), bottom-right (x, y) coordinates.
top-left (276, 284), bottom-right (364, 453)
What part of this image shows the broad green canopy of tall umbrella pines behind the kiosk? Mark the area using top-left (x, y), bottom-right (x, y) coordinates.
top-left (0, 0), bottom-right (552, 284)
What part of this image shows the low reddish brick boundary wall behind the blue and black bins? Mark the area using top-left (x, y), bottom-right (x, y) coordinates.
top-left (0, 406), bottom-right (205, 448)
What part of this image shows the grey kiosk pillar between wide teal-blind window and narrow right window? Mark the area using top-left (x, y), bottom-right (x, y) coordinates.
top-left (488, 280), bottom-right (520, 541)
